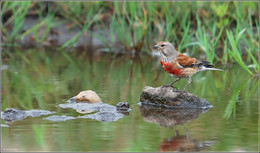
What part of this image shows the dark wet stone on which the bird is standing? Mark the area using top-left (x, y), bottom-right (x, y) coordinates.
top-left (140, 86), bottom-right (212, 108)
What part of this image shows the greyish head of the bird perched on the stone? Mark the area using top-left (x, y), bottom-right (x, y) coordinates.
top-left (153, 41), bottom-right (177, 58)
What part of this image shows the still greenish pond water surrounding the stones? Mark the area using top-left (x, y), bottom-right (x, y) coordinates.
top-left (1, 48), bottom-right (259, 152)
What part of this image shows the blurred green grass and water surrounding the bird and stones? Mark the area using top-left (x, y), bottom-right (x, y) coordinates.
top-left (1, 1), bottom-right (259, 151)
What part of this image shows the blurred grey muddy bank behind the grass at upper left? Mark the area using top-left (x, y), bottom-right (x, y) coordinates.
top-left (2, 17), bottom-right (117, 49)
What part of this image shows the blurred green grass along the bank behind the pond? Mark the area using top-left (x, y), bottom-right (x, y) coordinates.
top-left (1, 1), bottom-right (259, 76)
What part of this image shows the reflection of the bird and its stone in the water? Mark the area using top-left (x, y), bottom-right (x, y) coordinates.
top-left (140, 104), bottom-right (212, 152)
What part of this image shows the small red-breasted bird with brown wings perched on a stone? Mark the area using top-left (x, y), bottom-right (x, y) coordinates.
top-left (154, 41), bottom-right (223, 91)
